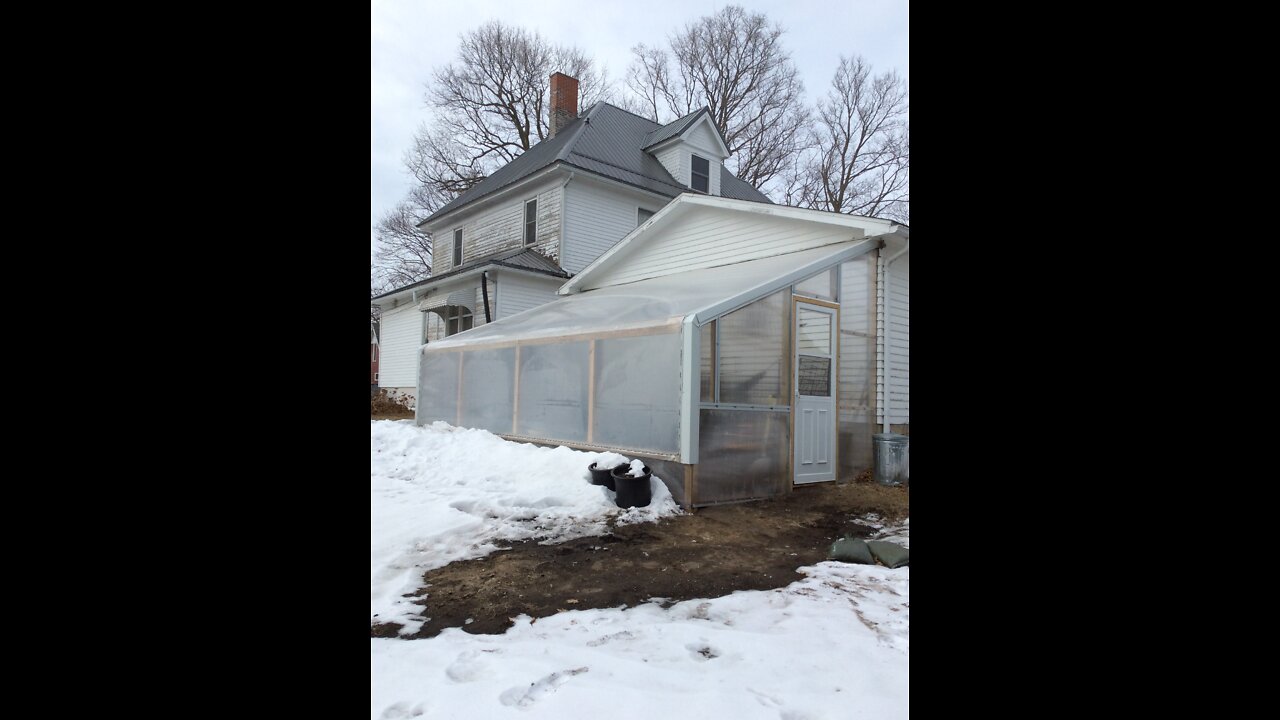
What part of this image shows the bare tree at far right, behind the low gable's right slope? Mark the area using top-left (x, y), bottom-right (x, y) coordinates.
top-left (783, 56), bottom-right (911, 222)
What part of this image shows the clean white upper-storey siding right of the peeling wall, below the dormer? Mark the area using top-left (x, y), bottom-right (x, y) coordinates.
top-left (561, 181), bottom-right (667, 274)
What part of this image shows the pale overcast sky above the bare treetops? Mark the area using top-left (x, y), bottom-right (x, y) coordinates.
top-left (369, 0), bottom-right (911, 257)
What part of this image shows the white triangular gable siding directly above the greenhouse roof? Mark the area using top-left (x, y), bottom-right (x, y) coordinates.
top-left (582, 209), bottom-right (858, 290)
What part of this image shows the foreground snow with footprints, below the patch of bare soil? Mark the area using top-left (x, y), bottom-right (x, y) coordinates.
top-left (370, 525), bottom-right (910, 720)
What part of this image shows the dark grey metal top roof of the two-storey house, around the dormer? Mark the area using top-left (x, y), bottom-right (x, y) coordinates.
top-left (419, 101), bottom-right (772, 227)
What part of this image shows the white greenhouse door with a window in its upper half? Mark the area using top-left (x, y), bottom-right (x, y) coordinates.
top-left (792, 299), bottom-right (837, 484)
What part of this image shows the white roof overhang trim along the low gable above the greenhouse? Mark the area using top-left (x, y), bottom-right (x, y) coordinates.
top-left (556, 192), bottom-right (908, 295)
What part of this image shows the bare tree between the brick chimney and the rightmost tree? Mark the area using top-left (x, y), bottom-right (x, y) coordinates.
top-left (627, 5), bottom-right (808, 187)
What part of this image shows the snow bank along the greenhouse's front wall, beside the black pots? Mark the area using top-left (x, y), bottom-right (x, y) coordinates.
top-left (370, 420), bottom-right (680, 633)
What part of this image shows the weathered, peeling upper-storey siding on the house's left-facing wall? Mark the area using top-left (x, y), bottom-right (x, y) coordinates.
top-left (433, 181), bottom-right (563, 275)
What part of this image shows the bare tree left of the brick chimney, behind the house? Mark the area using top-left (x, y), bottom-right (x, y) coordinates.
top-left (371, 20), bottom-right (609, 287)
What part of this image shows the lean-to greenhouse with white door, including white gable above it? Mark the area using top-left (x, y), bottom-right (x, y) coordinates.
top-left (417, 196), bottom-right (908, 506)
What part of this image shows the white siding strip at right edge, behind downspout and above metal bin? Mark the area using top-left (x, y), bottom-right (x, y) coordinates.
top-left (876, 252), bottom-right (911, 424)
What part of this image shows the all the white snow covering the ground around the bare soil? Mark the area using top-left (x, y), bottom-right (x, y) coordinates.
top-left (370, 421), bottom-right (910, 720)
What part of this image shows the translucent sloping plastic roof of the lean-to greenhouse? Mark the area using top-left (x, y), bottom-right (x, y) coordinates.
top-left (426, 238), bottom-right (881, 350)
